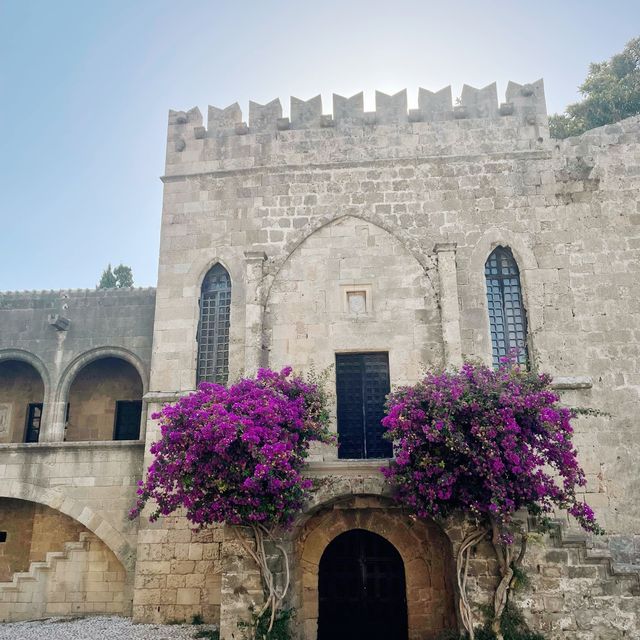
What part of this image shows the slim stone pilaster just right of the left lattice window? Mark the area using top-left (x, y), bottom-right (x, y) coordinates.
top-left (244, 251), bottom-right (267, 376)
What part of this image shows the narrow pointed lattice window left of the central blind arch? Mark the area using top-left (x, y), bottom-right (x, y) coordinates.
top-left (197, 264), bottom-right (231, 384)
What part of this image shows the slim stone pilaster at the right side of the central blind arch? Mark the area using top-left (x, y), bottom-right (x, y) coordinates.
top-left (434, 242), bottom-right (462, 367)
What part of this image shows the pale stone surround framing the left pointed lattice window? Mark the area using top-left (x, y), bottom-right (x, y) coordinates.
top-left (182, 246), bottom-right (246, 389)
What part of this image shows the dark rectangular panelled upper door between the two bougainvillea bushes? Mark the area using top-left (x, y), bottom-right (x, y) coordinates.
top-left (336, 353), bottom-right (393, 458)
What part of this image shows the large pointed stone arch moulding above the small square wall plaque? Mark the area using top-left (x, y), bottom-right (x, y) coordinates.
top-left (262, 212), bottom-right (436, 307)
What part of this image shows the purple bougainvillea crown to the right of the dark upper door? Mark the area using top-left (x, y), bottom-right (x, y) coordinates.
top-left (382, 362), bottom-right (600, 536)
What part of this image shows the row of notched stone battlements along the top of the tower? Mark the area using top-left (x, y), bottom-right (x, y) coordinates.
top-left (168, 79), bottom-right (547, 146)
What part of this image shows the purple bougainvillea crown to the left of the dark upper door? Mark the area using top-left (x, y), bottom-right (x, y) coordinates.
top-left (130, 368), bottom-right (331, 528)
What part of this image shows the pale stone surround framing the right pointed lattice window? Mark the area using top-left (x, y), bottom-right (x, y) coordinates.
top-left (468, 227), bottom-right (544, 364)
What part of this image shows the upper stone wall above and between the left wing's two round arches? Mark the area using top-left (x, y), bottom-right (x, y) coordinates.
top-left (0, 289), bottom-right (155, 442)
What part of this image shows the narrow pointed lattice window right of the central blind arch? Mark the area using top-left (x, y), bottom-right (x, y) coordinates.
top-left (484, 247), bottom-right (527, 366)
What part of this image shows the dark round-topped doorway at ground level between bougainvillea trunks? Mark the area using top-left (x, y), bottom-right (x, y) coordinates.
top-left (318, 529), bottom-right (408, 640)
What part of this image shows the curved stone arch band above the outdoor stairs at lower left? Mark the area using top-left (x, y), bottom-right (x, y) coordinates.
top-left (0, 480), bottom-right (135, 573)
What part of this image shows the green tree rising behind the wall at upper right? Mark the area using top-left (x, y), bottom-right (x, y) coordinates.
top-left (549, 37), bottom-right (640, 138)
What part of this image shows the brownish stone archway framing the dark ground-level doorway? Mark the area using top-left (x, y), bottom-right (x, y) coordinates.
top-left (292, 496), bottom-right (457, 640)
